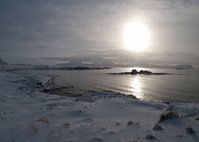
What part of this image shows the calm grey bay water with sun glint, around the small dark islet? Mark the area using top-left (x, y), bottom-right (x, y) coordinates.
top-left (19, 68), bottom-right (199, 102)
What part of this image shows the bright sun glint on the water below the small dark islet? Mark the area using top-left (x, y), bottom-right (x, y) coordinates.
top-left (131, 76), bottom-right (144, 99)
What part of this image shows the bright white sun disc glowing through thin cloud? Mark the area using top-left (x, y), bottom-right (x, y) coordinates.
top-left (123, 21), bottom-right (150, 52)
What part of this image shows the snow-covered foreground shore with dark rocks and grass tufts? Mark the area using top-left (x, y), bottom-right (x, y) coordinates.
top-left (0, 72), bottom-right (199, 142)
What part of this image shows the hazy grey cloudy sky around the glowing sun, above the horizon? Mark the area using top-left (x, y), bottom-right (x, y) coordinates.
top-left (0, 0), bottom-right (199, 65)
